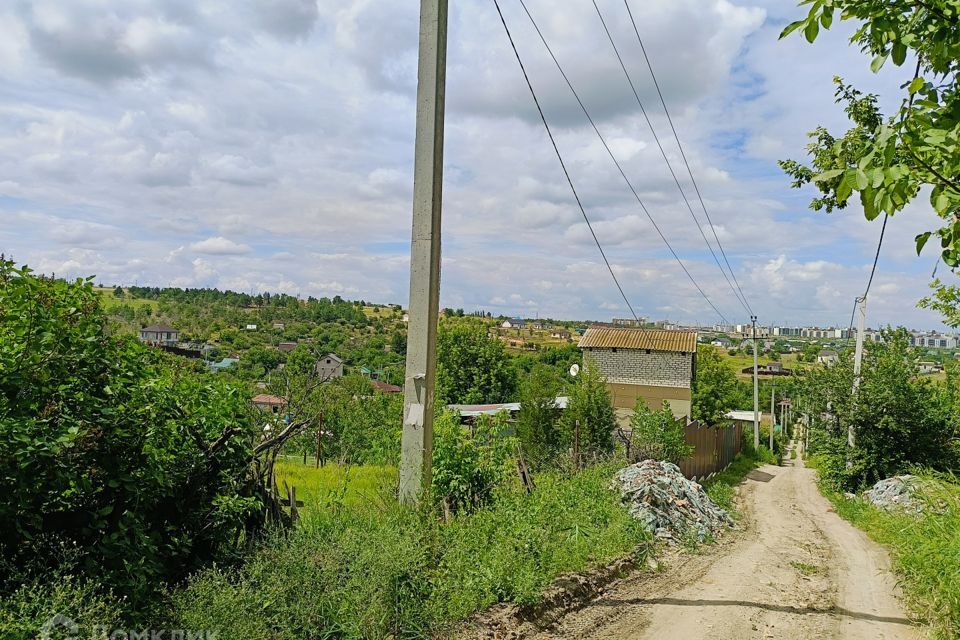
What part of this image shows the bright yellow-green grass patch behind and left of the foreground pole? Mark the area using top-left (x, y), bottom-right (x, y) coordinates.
top-left (276, 457), bottom-right (398, 509)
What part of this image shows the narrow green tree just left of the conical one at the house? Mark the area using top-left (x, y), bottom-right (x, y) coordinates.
top-left (516, 365), bottom-right (563, 466)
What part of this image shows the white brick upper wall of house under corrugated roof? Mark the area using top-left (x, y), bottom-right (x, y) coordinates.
top-left (584, 348), bottom-right (693, 389)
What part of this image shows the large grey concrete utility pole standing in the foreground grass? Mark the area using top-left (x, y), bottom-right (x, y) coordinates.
top-left (400, 0), bottom-right (447, 504)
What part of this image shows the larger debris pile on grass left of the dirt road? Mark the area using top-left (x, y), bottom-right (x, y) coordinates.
top-left (612, 460), bottom-right (733, 543)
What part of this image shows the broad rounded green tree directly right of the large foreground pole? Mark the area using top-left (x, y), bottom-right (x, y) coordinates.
top-left (437, 322), bottom-right (517, 404)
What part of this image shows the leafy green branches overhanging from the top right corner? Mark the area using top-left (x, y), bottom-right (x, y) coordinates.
top-left (780, 0), bottom-right (960, 268)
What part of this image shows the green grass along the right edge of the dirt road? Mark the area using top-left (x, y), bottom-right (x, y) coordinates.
top-left (821, 474), bottom-right (960, 639)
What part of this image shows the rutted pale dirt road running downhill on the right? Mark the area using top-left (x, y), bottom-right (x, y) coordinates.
top-left (532, 450), bottom-right (923, 640)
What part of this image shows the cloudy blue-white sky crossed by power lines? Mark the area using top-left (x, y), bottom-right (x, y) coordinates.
top-left (0, 0), bottom-right (953, 329)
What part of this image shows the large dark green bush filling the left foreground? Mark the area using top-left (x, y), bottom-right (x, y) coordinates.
top-left (0, 261), bottom-right (257, 603)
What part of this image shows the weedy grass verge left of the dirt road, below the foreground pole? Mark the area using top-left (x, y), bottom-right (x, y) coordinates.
top-left (172, 466), bottom-right (650, 640)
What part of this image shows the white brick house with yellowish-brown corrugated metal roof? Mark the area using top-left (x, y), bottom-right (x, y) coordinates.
top-left (578, 327), bottom-right (697, 423)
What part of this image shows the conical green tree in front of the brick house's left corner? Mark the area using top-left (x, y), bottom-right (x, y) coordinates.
top-left (561, 364), bottom-right (617, 455)
